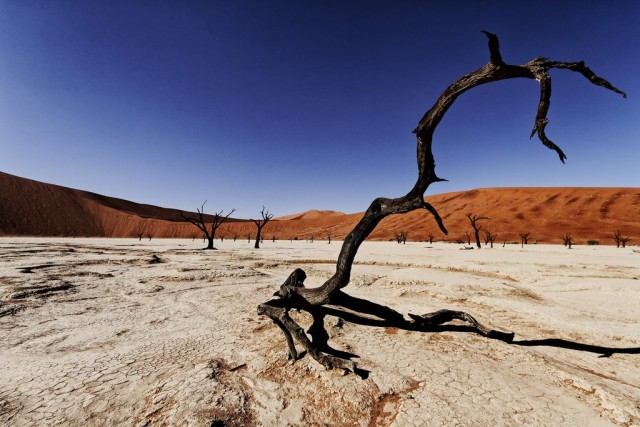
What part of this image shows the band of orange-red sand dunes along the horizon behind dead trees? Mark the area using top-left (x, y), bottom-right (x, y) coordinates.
top-left (0, 172), bottom-right (640, 244)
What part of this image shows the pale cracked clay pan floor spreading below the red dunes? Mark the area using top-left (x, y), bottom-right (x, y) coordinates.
top-left (0, 238), bottom-right (640, 426)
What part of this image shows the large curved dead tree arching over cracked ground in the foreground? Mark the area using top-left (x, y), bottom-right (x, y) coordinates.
top-left (257, 31), bottom-right (626, 374)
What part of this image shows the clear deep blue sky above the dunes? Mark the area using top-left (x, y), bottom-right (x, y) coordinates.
top-left (0, 0), bottom-right (640, 218)
